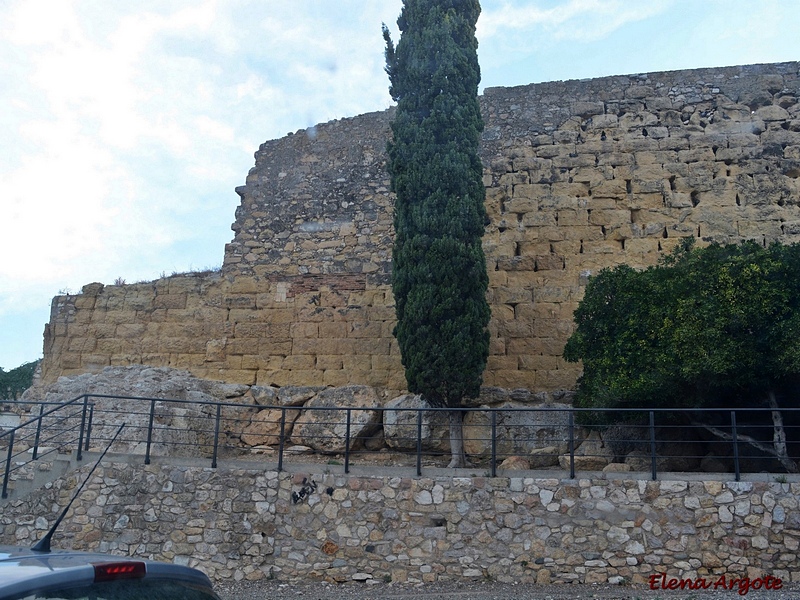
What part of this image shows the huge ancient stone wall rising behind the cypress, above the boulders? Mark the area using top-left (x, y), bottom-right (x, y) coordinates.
top-left (43, 62), bottom-right (800, 391)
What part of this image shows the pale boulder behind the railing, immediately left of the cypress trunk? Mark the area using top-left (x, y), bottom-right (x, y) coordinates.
top-left (383, 394), bottom-right (450, 452)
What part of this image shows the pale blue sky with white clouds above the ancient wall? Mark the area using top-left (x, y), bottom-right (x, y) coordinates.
top-left (0, 0), bottom-right (800, 370)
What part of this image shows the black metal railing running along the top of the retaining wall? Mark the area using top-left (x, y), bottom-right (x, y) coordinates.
top-left (0, 394), bottom-right (800, 498)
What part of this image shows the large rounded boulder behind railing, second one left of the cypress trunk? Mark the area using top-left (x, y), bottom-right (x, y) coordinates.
top-left (292, 385), bottom-right (381, 453)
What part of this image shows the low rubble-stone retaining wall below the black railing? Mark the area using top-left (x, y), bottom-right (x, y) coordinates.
top-left (0, 459), bottom-right (800, 584)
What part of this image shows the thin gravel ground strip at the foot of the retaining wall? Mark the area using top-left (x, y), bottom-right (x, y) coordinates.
top-left (217, 581), bottom-right (800, 600)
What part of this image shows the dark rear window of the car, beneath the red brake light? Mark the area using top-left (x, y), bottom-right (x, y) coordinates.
top-left (14, 579), bottom-right (219, 600)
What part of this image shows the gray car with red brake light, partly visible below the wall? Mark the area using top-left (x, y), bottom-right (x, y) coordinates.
top-left (0, 546), bottom-right (219, 600)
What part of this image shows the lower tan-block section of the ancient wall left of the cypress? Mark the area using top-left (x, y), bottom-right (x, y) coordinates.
top-left (41, 273), bottom-right (405, 391)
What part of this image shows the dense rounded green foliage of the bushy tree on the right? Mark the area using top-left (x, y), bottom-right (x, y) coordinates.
top-left (564, 242), bottom-right (800, 407)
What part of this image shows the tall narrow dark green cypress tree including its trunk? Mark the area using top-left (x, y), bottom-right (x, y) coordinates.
top-left (383, 0), bottom-right (490, 467)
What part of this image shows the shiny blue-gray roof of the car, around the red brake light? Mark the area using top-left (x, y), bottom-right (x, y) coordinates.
top-left (0, 546), bottom-right (219, 599)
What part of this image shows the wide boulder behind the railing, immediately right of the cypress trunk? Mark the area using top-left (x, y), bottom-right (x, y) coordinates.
top-left (464, 402), bottom-right (583, 456)
